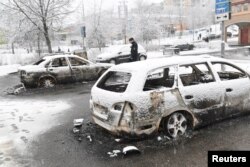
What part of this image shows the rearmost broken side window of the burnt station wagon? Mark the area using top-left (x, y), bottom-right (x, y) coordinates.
top-left (143, 67), bottom-right (175, 91)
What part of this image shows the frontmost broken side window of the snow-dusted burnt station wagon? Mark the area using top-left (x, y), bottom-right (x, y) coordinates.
top-left (212, 62), bottom-right (247, 81)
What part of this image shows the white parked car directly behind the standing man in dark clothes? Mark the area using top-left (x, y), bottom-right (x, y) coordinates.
top-left (96, 44), bottom-right (147, 64)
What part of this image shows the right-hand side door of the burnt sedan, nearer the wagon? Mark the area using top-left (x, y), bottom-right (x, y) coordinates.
top-left (68, 57), bottom-right (98, 82)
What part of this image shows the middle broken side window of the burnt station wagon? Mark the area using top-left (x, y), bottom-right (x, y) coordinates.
top-left (179, 63), bottom-right (215, 86)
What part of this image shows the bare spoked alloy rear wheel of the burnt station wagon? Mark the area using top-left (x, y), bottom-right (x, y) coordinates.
top-left (163, 112), bottom-right (188, 138)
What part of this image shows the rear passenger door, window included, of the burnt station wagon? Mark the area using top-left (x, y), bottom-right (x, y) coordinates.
top-left (179, 62), bottom-right (224, 124)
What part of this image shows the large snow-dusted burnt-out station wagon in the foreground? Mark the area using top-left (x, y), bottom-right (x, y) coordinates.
top-left (90, 56), bottom-right (250, 138)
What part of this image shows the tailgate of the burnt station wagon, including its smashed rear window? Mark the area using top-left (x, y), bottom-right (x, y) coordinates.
top-left (90, 71), bottom-right (131, 126)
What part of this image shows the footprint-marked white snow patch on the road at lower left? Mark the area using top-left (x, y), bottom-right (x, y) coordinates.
top-left (0, 99), bottom-right (70, 167)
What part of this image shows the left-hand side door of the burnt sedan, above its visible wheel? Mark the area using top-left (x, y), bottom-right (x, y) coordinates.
top-left (47, 57), bottom-right (72, 83)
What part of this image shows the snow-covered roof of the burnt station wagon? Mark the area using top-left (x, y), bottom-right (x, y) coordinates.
top-left (110, 55), bottom-right (230, 72)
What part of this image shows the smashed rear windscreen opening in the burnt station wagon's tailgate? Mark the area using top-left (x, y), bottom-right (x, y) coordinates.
top-left (97, 71), bottom-right (131, 92)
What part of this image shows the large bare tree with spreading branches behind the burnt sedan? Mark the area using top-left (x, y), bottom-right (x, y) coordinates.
top-left (0, 0), bottom-right (72, 53)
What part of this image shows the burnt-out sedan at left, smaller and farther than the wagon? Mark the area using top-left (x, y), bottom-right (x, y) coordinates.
top-left (19, 55), bottom-right (112, 87)
